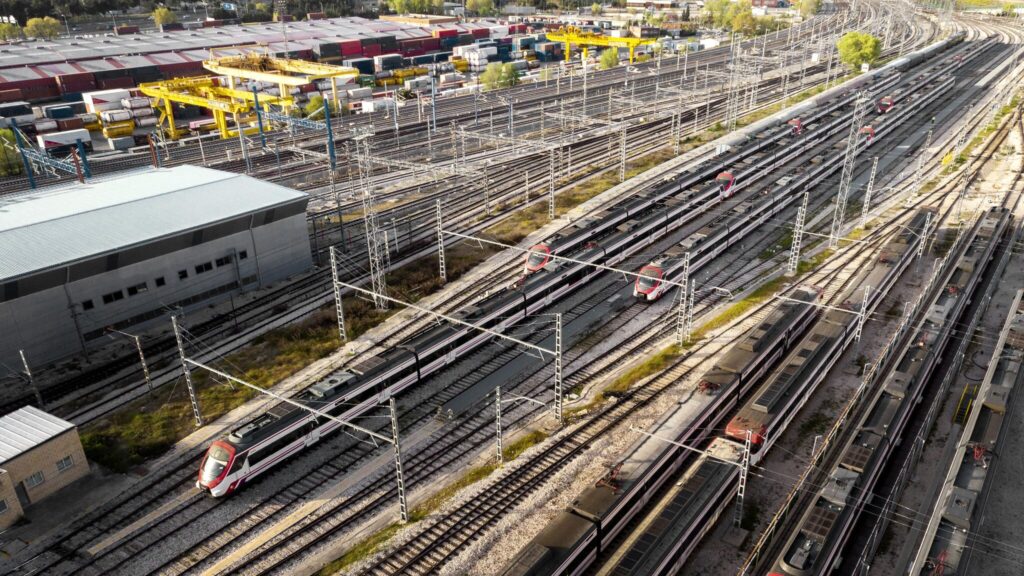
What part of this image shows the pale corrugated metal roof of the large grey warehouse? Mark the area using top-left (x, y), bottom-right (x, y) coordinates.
top-left (0, 165), bottom-right (307, 281)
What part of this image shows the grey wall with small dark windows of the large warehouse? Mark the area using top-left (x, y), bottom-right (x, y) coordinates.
top-left (0, 213), bottom-right (311, 367)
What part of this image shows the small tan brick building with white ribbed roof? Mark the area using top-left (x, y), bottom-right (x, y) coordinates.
top-left (0, 406), bottom-right (89, 530)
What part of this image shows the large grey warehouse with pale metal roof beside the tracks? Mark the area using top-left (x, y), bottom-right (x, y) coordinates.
top-left (0, 166), bottom-right (311, 366)
